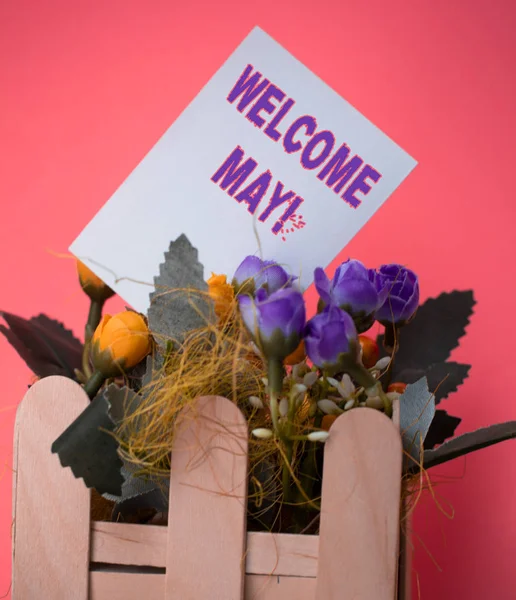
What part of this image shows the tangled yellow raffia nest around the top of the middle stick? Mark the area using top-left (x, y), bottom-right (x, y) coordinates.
top-left (115, 290), bottom-right (286, 504)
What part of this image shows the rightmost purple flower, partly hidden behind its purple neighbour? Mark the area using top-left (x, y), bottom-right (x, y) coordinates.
top-left (376, 264), bottom-right (419, 326)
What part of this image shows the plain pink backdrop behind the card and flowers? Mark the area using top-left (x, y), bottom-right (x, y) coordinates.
top-left (0, 0), bottom-right (516, 600)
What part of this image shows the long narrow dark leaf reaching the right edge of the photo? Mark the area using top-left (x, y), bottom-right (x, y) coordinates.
top-left (424, 421), bottom-right (516, 469)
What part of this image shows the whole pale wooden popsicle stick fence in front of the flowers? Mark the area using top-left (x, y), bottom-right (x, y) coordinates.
top-left (12, 377), bottom-right (408, 600)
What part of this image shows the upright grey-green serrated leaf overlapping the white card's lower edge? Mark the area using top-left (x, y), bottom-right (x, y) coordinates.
top-left (148, 235), bottom-right (212, 349)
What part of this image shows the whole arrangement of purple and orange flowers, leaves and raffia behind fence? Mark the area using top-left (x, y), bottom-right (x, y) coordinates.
top-left (0, 236), bottom-right (516, 532)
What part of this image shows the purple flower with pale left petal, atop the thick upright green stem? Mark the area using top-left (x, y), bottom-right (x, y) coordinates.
top-left (238, 288), bottom-right (306, 361)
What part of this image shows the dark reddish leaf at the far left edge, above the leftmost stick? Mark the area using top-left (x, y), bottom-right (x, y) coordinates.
top-left (0, 312), bottom-right (82, 379)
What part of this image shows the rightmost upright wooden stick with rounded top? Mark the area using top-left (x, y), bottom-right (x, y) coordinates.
top-left (316, 408), bottom-right (402, 600)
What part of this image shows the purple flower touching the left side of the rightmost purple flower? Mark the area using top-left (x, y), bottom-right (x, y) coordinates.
top-left (314, 259), bottom-right (387, 333)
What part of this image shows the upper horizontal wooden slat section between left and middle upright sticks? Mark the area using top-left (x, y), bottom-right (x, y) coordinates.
top-left (91, 521), bottom-right (167, 568)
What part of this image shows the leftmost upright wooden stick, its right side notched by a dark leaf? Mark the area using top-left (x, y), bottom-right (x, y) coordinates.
top-left (12, 377), bottom-right (90, 600)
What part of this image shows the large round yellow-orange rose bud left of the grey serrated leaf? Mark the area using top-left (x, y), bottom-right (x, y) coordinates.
top-left (92, 310), bottom-right (151, 377)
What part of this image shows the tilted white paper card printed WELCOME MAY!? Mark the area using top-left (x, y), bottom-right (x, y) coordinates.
top-left (70, 28), bottom-right (416, 312)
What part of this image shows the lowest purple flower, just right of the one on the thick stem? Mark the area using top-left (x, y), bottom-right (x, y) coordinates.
top-left (305, 305), bottom-right (358, 373)
